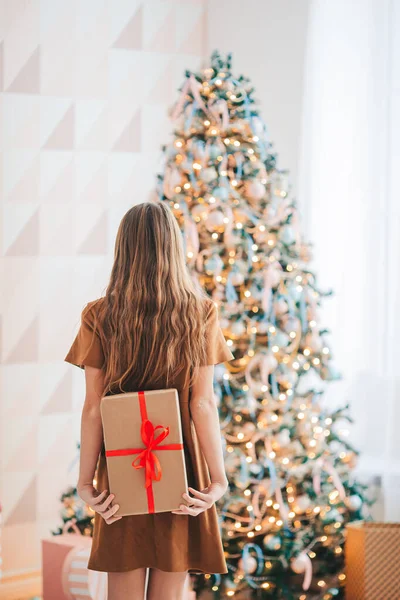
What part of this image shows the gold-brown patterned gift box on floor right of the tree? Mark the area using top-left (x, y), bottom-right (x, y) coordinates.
top-left (345, 521), bottom-right (400, 600)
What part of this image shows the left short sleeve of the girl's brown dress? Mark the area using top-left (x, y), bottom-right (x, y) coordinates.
top-left (64, 303), bottom-right (104, 369)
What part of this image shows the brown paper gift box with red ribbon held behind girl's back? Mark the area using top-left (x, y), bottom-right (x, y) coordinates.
top-left (100, 388), bottom-right (187, 516)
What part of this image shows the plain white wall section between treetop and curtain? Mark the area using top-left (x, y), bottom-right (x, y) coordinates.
top-left (206, 0), bottom-right (310, 193)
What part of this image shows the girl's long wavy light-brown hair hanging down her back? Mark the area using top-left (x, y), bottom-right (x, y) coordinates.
top-left (97, 201), bottom-right (212, 394)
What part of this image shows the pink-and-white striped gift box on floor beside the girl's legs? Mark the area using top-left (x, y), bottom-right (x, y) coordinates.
top-left (62, 547), bottom-right (107, 600)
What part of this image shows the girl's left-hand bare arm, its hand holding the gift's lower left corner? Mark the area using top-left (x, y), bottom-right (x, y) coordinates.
top-left (77, 365), bottom-right (122, 524)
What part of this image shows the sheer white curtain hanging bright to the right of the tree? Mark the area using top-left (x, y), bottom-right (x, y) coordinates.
top-left (299, 0), bottom-right (400, 520)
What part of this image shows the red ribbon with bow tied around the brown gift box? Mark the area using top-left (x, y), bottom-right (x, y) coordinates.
top-left (106, 392), bottom-right (183, 513)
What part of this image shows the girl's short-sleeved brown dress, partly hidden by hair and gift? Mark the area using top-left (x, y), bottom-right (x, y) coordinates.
top-left (64, 298), bottom-right (234, 573)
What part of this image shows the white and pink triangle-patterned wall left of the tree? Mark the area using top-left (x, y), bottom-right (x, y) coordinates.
top-left (0, 0), bottom-right (206, 574)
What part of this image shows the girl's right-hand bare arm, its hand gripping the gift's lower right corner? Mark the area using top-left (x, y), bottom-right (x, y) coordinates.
top-left (173, 365), bottom-right (228, 516)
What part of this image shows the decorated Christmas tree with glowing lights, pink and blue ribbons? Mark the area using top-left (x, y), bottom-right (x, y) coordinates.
top-left (158, 53), bottom-right (368, 600)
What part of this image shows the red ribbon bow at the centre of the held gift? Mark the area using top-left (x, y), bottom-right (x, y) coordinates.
top-left (132, 419), bottom-right (169, 487)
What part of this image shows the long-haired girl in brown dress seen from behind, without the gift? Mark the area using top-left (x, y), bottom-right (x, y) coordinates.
top-left (64, 202), bottom-right (234, 600)
